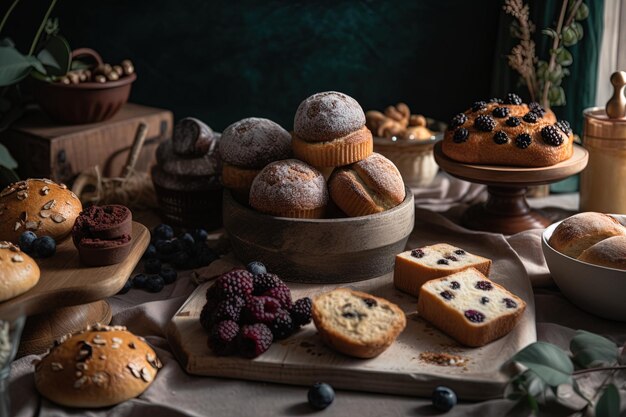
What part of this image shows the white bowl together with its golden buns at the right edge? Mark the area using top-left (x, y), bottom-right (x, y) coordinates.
top-left (542, 212), bottom-right (626, 321)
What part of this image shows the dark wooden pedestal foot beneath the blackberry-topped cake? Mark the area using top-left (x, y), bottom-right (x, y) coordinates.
top-left (461, 186), bottom-right (550, 235)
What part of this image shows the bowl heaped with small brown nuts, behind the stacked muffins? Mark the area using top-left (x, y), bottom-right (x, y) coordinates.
top-left (366, 103), bottom-right (446, 187)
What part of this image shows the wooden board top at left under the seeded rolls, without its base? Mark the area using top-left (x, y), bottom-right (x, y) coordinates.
top-left (0, 222), bottom-right (150, 316)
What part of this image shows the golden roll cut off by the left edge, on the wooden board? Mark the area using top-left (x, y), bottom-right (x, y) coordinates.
top-left (0, 242), bottom-right (40, 302)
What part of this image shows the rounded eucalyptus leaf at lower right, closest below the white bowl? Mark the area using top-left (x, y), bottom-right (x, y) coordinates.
top-left (569, 330), bottom-right (618, 368)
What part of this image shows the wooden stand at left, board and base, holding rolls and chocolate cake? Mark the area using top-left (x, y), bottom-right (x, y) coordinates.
top-left (0, 222), bottom-right (150, 356)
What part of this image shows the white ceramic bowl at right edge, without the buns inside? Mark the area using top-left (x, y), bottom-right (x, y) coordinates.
top-left (541, 215), bottom-right (626, 321)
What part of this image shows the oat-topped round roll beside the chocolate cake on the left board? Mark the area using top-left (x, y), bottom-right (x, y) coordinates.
top-left (0, 178), bottom-right (83, 243)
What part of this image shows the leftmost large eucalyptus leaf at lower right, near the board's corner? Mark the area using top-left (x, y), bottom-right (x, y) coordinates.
top-left (512, 342), bottom-right (574, 386)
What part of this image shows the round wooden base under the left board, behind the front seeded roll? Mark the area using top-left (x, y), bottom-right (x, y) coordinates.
top-left (17, 301), bottom-right (111, 357)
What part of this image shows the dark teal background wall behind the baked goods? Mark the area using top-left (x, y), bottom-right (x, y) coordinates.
top-left (9, 0), bottom-right (501, 130)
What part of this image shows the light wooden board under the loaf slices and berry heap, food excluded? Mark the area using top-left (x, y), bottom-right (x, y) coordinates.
top-left (167, 272), bottom-right (537, 400)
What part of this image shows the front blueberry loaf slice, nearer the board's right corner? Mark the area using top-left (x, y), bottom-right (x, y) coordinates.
top-left (417, 268), bottom-right (526, 346)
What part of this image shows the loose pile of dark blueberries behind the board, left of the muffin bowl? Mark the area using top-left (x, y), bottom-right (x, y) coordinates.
top-left (120, 224), bottom-right (218, 294)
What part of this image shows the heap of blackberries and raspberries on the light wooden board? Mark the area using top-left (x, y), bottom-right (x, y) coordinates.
top-left (200, 262), bottom-right (311, 358)
